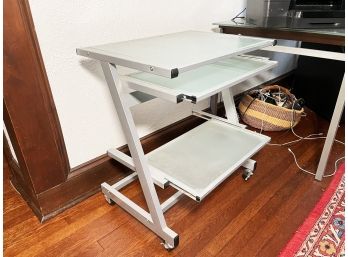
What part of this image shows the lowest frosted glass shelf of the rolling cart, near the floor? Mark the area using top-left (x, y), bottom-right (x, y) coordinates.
top-left (146, 120), bottom-right (270, 201)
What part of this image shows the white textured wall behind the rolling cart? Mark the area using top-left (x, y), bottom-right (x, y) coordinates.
top-left (29, 0), bottom-right (245, 167)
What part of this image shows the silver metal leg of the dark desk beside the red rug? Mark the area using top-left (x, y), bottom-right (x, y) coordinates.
top-left (315, 75), bottom-right (345, 180)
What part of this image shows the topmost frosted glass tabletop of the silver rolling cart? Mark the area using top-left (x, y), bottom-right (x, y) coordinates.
top-left (77, 31), bottom-right (274, 75)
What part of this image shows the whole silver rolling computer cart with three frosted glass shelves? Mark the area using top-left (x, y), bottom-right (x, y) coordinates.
top-left (77, 31), bottom-right (276, 249)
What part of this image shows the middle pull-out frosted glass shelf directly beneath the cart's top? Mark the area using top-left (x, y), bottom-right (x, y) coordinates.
top-left (121, 56), bottom-right (277, 103)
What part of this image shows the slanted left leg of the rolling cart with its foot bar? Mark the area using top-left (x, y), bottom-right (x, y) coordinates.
top-left (101, 62), bottom-right (179, 248)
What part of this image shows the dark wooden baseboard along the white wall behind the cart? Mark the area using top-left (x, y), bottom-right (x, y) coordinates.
top-left (35, 116), bottom-right (203, 222)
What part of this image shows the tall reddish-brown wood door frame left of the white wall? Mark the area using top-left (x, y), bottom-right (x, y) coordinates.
top-left (4, 0), bottom-right (70, 194)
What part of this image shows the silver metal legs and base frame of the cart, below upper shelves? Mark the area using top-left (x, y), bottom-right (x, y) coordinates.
top-left (100, 58), bottom-right (270, 249)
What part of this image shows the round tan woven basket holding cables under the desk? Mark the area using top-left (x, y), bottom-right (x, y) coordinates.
top-left (238, 85), bottom-right (304, 131)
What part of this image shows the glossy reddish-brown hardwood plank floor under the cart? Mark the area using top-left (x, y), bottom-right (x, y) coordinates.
top-left (4, 108), bottom-right (344, 257)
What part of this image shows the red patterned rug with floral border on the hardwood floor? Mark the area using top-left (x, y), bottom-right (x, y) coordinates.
top-left (279, 164), bottom-right (345, 257)
